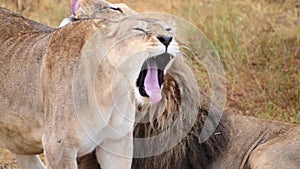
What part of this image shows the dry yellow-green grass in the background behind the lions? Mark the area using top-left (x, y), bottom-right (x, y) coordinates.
top-left (0, 0), bottom-right (300, 169)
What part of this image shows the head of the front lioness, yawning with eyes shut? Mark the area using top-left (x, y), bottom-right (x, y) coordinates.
top-left (100, 16), bottom-right (179, 104)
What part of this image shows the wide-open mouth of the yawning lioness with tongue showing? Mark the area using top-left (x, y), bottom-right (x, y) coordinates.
top-left (136, 53), bottom-right (174, 104)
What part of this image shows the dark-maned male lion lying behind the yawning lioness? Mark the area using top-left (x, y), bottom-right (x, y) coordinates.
top-left (79, 59), bottom-right (300, 169)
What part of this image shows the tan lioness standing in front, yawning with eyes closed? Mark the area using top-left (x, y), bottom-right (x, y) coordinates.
top-left (0, 8), bottom-right (180, 169)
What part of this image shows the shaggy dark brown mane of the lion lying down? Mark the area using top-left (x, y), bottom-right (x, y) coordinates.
top-left (132, 57), bottom-right (229, 169)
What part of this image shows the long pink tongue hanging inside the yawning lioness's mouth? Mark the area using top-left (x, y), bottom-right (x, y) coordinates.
top-left (144, 62), bottom-right (162, 104)
